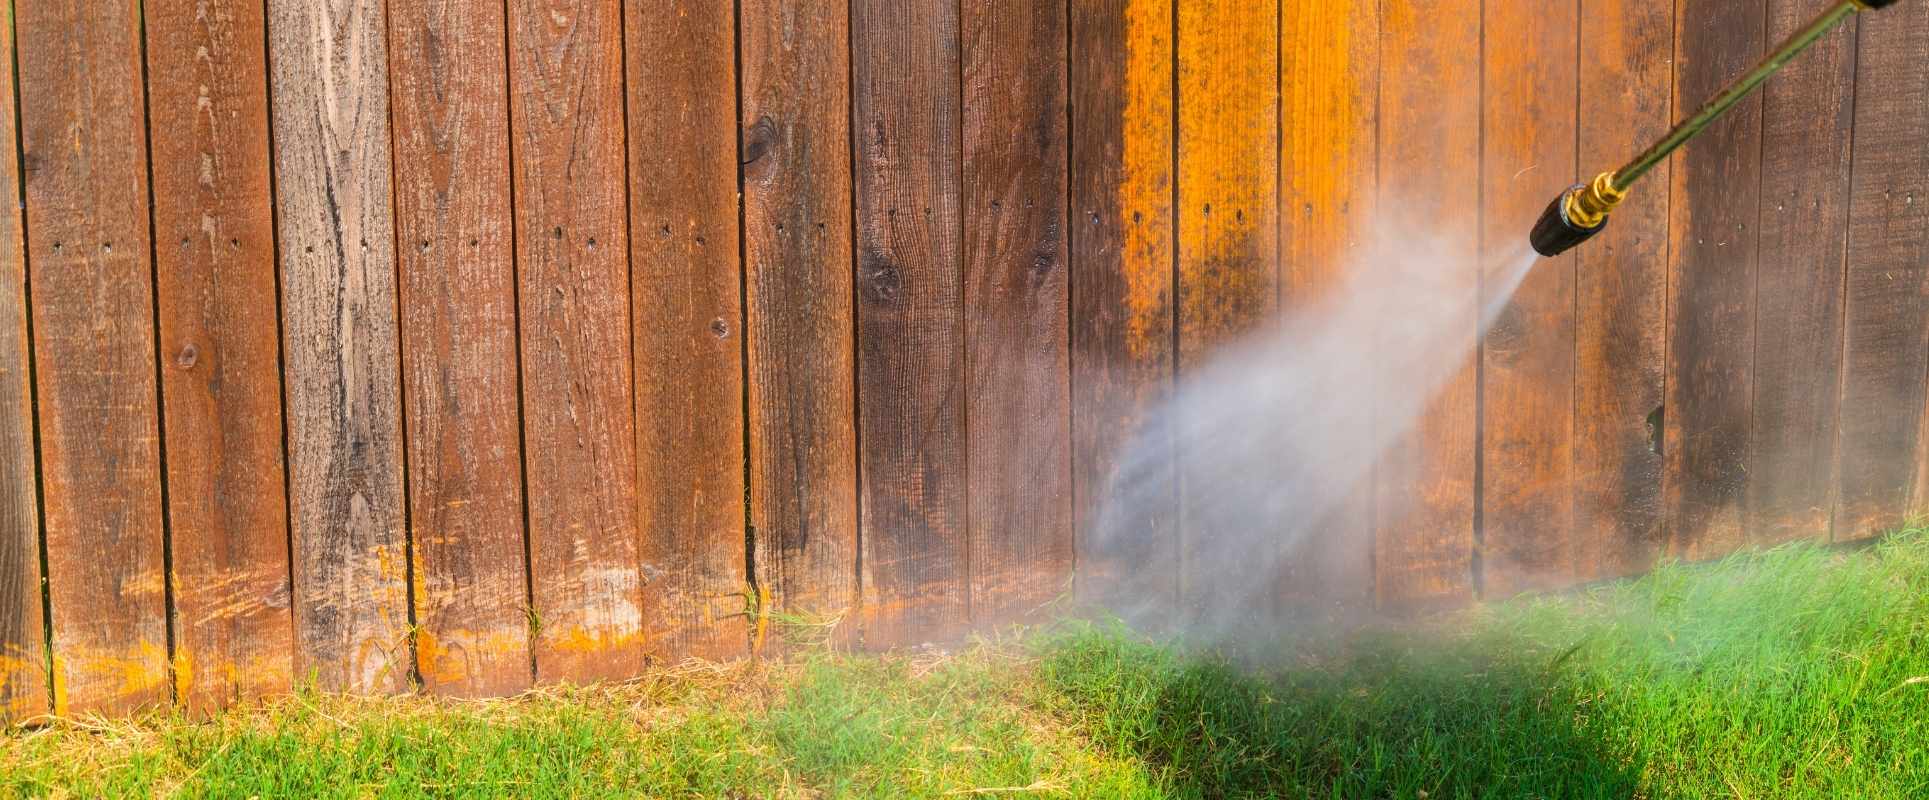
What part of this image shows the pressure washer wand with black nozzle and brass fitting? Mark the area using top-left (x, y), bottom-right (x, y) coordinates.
top-left (1528, 0), bottom-right (1896, 256)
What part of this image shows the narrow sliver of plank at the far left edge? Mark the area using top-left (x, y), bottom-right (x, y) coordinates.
top-left (0, 17), bottom-right (50, 723)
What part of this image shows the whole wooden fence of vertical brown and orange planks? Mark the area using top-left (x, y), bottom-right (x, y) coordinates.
top-left (0, 0), bottom-right (1929, 717)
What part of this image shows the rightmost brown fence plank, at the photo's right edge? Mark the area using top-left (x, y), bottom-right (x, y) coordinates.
top-left (1834, 4), bottom-right (1929, 542)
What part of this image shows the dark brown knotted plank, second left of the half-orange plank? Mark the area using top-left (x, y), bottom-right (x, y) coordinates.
top-left (851, 0), bottom-right (976, 646)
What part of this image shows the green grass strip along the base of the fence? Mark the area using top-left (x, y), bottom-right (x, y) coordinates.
top-left (0, 532), bottom-right (1929, 798)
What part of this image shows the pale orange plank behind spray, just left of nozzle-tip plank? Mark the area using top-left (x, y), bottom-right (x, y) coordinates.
top-left (1373, 0), bottom-right (1481, 607)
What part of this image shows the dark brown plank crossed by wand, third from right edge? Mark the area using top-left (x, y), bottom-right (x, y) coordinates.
top-left (1663, 0), bottom-right (1765, 559)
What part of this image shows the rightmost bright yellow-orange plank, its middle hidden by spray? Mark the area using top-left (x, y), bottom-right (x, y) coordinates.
top-left (1279, 0), bottom-right (1379, 617)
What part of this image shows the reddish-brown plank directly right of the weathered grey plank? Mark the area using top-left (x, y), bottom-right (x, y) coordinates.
top-left (388, 0), bottom-right (530, 698)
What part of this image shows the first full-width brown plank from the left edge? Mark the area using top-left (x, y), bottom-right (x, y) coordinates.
top-left (14, 2), bottom-right (170, 713)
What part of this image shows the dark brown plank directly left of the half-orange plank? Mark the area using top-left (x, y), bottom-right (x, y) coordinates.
top-left (961, 0), bottom-right (1073, 627)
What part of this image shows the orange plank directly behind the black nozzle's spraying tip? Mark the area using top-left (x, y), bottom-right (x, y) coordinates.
top-left (1480, 0), bottom-right (1580, 598)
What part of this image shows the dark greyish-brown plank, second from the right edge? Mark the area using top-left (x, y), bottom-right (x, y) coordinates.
top-left (1744, 0), bottom-right (1851, 546)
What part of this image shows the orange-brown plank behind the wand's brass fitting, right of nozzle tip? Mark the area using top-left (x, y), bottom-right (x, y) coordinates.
top-left (1572, 0), bottom-right (1674, 578)
